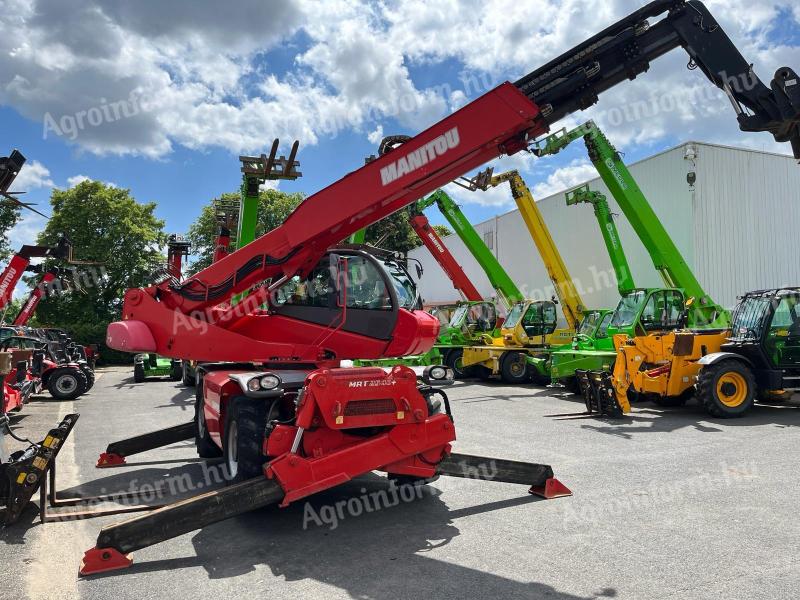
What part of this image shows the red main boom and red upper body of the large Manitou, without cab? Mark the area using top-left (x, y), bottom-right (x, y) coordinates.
top-left (108, 83), bottom-right (547, 362)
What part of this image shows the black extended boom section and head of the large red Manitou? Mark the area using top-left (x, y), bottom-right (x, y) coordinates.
top-left (515, 0), bottom-right (800, 158)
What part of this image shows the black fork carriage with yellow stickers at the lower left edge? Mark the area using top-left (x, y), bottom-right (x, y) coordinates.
top-left (0, 414), bottom-right (80, 525)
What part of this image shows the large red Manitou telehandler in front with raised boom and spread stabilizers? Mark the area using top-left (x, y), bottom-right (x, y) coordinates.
top-left (4, 0), bottom-right (800, 575)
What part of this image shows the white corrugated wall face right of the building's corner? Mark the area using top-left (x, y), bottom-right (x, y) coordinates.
top-left (694, 144), bottom-right (800, 307)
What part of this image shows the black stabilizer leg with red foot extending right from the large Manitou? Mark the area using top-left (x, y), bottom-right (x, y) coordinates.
top-left (436, 454), bottom-right (572, 499)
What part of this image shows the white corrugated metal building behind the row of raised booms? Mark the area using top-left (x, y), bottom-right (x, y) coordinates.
top-left (410, 142), bottom-right (800, 318)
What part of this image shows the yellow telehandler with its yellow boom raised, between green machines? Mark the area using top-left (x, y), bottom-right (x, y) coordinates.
top-left (462, 169), bottom-right (586, 384)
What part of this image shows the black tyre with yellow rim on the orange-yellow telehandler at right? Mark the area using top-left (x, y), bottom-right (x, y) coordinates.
top-left (697, 360), bottom-right (756, 418)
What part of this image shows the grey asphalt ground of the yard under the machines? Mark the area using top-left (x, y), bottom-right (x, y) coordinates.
top-left (0, 368), bottom-right (800, 600)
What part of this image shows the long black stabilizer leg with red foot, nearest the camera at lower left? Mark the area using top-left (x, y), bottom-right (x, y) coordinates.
top-left (79, 477), bottom-right (284, 575)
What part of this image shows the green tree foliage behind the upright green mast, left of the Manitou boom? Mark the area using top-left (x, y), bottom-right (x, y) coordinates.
top-left (187, 190), bottom-right (303, 275)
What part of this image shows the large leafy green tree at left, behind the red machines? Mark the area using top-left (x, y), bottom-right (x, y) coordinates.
top-left (27, 181), bottom-right (166, 350)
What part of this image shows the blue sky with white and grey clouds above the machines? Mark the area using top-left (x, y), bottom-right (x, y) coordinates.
top-left (0, 0), bottom-right (800, 290)
